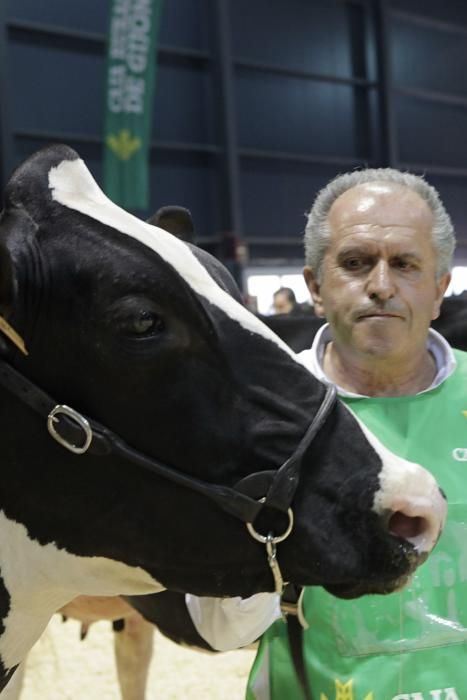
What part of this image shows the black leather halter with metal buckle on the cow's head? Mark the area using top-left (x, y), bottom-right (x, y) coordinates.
top-left (0, 360), bottom-right (336, 542)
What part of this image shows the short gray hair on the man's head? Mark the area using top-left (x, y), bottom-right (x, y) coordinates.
top-left (305, 168), bottom-right (456, 279)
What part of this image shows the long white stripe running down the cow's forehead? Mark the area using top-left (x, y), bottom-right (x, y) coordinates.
top-left (49, 159), bottom-right (295, 357)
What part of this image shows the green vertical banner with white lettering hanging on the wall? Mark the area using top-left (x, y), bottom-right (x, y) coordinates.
top-left (104, 0), bottom-right (162, 209)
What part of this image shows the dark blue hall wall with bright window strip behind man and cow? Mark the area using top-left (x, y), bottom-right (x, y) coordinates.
top-left (0, 0), bottom-right (467, 314)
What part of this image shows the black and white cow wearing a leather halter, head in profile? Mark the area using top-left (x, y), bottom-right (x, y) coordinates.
top-left (0, 146), bottom-right (445, 687)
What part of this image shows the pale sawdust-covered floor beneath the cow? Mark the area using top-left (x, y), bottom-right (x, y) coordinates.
top-left (21, 615), bottom-right (255, 700)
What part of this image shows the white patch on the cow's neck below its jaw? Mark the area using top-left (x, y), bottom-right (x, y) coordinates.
top-left (0, 511), bottom-right (163, 668)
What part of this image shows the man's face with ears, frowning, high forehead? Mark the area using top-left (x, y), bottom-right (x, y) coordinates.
top-left (305, 182), bottom-right (449, 358)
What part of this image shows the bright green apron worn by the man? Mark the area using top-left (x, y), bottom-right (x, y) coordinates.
top-left (247, 351), bottom-right (467, 700)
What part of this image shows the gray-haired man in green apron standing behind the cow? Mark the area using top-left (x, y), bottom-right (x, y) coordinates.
top-left (187, 169), bottom-right (467, 700)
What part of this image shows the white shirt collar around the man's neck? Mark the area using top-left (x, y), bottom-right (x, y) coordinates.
top-left (298, 323), bottom-right (457, 398)
